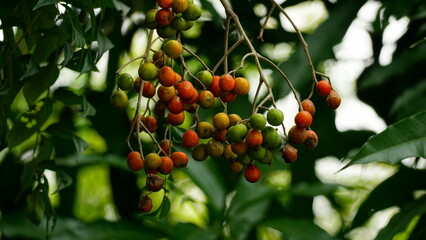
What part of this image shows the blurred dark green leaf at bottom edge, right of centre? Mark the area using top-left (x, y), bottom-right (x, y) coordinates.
top-left (264, 218), bottom-right (334, 240)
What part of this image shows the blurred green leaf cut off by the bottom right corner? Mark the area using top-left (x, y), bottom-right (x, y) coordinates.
top-left (376, 197), bottom-right (426, 240)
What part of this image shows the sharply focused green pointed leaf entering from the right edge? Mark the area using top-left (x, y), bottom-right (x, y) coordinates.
top-left (344, 111), bottom-right (426, 168)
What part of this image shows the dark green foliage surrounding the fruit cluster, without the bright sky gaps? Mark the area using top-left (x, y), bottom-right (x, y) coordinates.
top-left (0, 0), bottom-right (426, 239)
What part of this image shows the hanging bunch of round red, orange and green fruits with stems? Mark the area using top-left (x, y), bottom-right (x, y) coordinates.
top-left (111, 0), bottom-right (340, 212)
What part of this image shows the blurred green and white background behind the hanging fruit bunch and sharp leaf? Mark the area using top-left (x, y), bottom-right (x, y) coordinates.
top-left (0, 0), bottom-right (426, 240)
